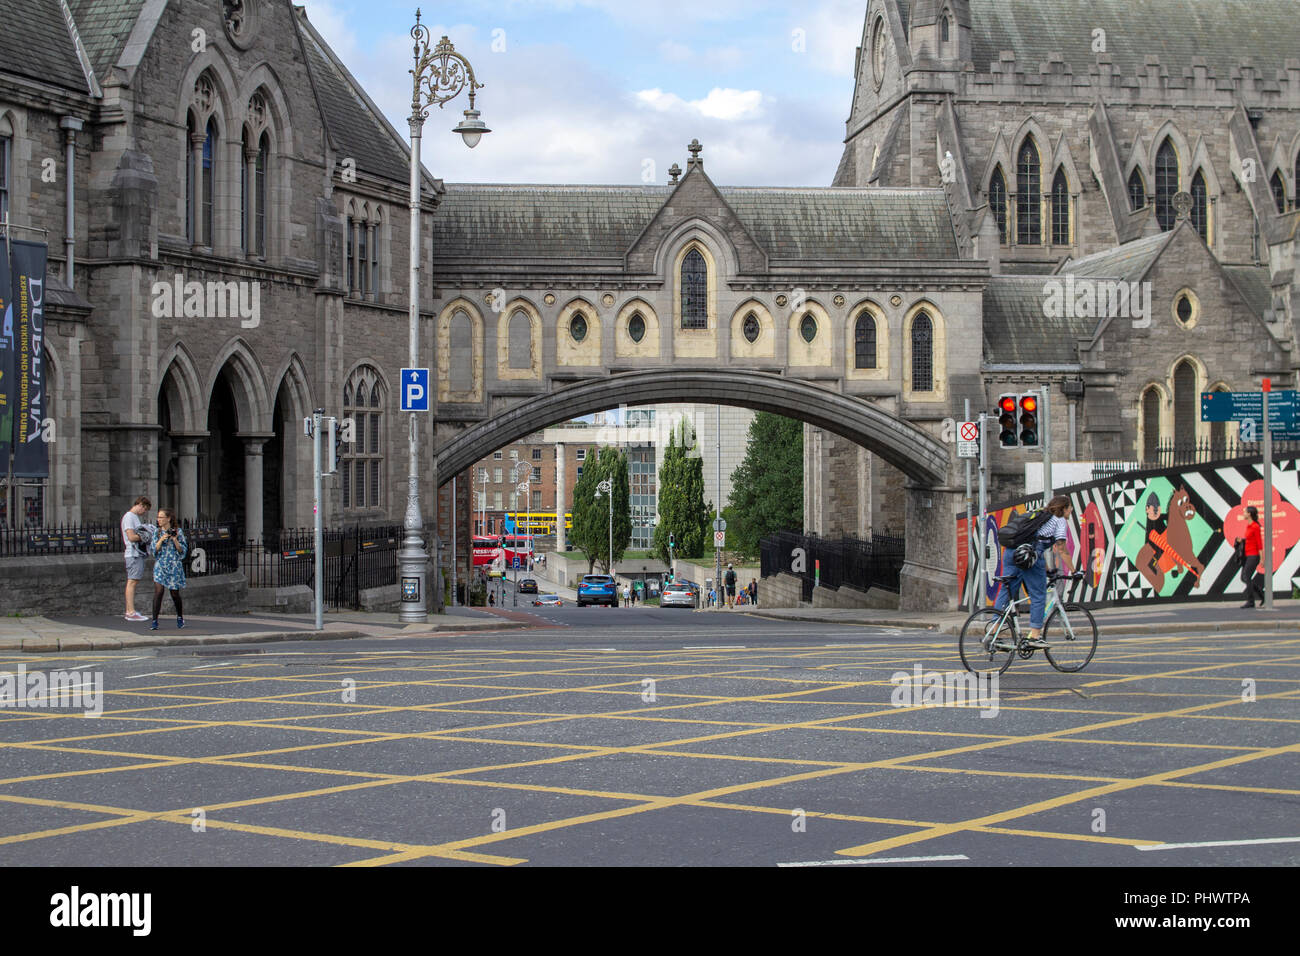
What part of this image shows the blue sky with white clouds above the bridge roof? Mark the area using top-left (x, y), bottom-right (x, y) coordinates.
top-left (299, 0), bottom-right (867, 186)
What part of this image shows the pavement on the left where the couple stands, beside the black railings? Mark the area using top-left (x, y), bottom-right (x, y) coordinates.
top-left (0, 607), bottom-right (529, 653)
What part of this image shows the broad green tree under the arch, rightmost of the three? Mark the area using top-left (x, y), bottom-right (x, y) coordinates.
top-left (727, 411), bottom-right (803, 558)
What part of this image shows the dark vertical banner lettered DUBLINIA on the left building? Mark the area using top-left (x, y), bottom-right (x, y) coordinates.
top-left (10, 241), bottom-right (49, 477)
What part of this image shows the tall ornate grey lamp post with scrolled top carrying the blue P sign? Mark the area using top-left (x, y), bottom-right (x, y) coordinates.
top-left (398, 9), bottom-right (490, 624)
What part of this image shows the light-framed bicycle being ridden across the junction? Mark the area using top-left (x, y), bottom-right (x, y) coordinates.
top-left (957, 571), bottom-right (1097, 674)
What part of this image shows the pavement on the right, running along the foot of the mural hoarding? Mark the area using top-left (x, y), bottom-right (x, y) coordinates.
top-left (735, 600), bottom-right (1300, 635)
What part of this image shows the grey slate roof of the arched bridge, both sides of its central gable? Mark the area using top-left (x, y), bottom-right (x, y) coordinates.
top-left (433, 183), bottom-right (957, 261)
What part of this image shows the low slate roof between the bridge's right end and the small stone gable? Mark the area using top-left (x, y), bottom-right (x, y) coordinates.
top-left (984, 276), bottom-right (1097, 365)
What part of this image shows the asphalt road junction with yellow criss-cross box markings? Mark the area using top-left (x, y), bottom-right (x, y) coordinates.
top-left (0, 606), bottom-right (1300, 866)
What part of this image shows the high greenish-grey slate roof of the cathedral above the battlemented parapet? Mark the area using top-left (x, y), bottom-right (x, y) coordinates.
top-left (970, 0), bottom-right (1300, 81)
